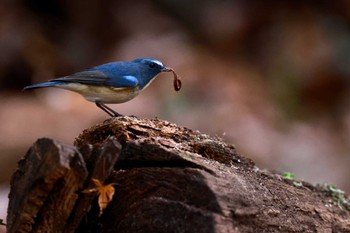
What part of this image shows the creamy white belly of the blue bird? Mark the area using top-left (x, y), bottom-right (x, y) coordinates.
top-left (57, 83), bottom-right (140, 104)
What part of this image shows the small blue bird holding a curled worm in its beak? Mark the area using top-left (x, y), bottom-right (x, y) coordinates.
top-left (24, 58), bottom-right (181, 117)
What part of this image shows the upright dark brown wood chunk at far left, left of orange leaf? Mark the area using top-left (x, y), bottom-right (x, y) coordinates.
top-left (7, 138), bottom-right (88, 233)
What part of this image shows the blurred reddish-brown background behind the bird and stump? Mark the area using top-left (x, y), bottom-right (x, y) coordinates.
top-left (0, 0), bottom-right (350, 225)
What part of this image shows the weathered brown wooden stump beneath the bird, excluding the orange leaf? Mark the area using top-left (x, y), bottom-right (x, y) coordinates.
top-left (7, 116), bottom-right (350, 233)
